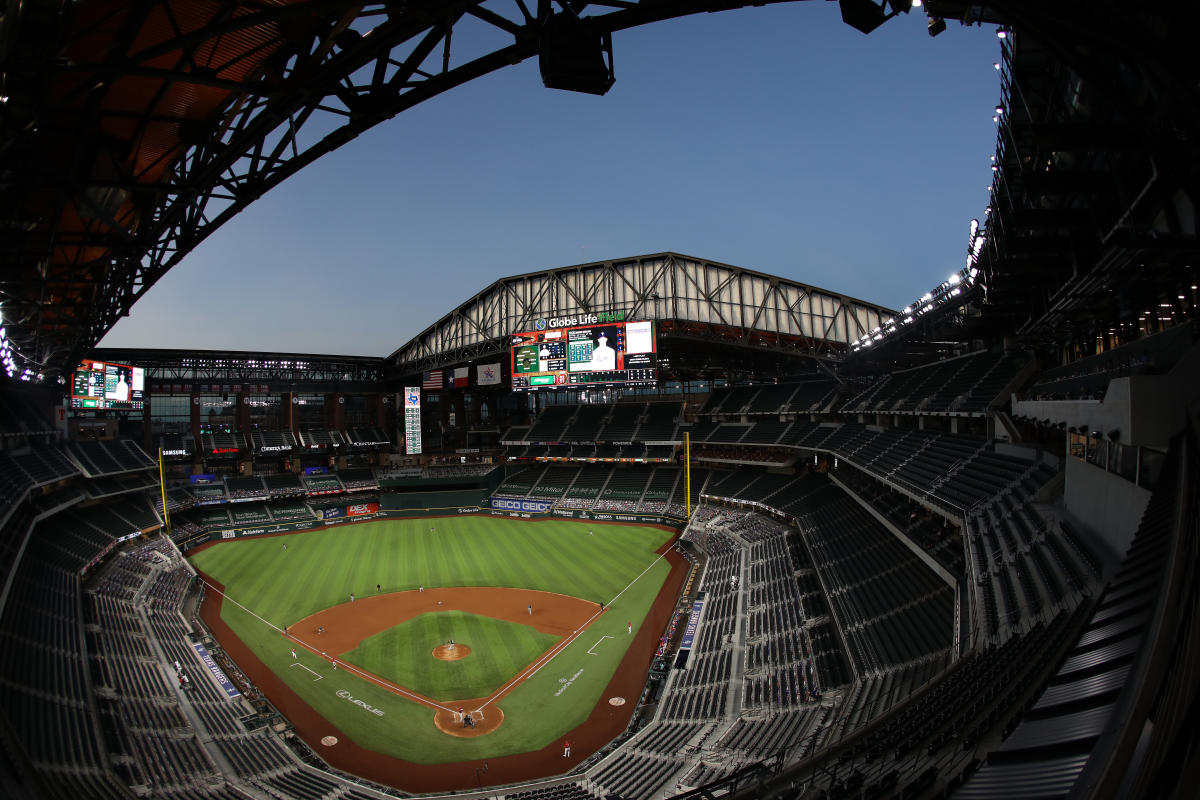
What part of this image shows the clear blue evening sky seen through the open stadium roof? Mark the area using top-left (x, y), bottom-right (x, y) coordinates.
top-left (101, 2), bottom-right (1000, 355)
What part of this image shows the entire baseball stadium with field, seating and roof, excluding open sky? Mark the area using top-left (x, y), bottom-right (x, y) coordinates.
top-left (0, 0), bottom-right (1200, 800)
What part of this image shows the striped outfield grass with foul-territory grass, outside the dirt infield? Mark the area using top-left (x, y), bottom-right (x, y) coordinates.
top-left (192, 517), bottom-right (671, 764)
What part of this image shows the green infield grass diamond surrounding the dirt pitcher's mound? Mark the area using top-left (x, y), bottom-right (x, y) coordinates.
top-left (343, 610), bottom-right (559, 700)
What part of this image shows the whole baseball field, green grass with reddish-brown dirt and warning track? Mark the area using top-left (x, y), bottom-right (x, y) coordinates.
top-left (191, 516), bottom-right (682, 789)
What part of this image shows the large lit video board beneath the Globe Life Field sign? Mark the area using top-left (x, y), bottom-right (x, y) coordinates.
top-left (510, 315), bottom-right (659, 392)
